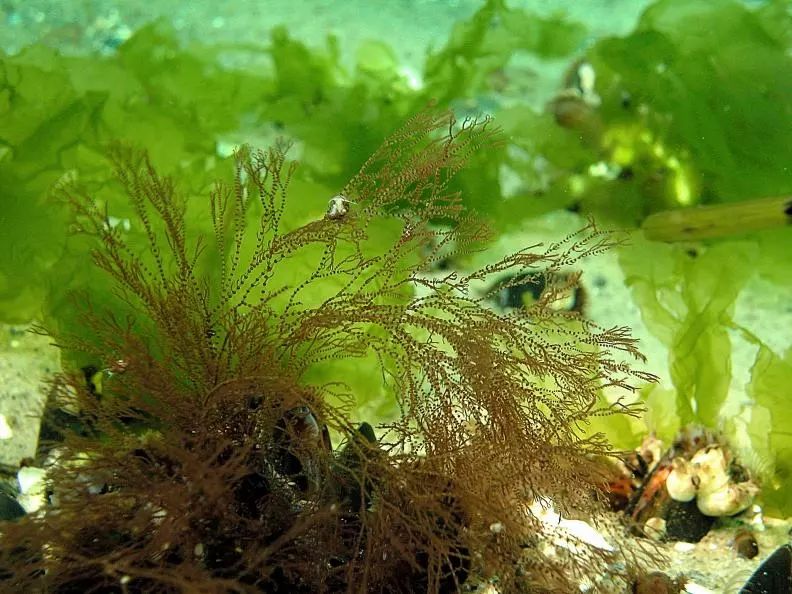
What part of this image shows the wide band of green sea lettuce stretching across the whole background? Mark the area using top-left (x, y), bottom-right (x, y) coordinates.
top-left (6, 0), bottom-right (792, 332)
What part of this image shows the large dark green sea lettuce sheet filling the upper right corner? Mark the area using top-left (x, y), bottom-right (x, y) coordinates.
top-left (588, 0), bottom-right (792, 203)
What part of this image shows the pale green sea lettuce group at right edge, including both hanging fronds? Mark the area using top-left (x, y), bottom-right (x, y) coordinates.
top-left (620, 234), bottom-right (792, 516)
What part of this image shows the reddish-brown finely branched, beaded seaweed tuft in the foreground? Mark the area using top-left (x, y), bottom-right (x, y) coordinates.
top-left (0, 109), bottom-right (650, 594)
